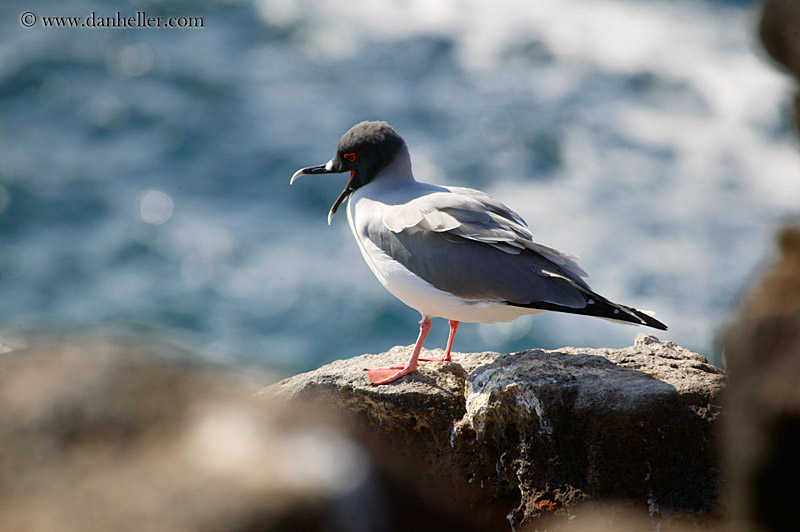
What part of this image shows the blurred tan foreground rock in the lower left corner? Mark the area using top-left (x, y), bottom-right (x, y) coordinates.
top-left (0, 341), bottom-right (390, 532)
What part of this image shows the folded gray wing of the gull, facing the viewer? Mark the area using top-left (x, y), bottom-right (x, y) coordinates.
top-left (372, 187), bottom-right (591, 309)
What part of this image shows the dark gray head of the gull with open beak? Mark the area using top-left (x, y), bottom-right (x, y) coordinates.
top-left (289, 122), bottom-right (406, 224)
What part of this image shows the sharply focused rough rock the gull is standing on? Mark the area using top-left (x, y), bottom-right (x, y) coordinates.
top-left (262, 335), bottom-right (725, 530)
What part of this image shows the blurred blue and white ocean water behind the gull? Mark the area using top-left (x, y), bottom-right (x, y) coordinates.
top-left (0, 0), bottom-right (800, 371)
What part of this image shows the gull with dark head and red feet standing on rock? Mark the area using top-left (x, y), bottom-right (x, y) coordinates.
top-left (289, 121), bottom-right (667, 386)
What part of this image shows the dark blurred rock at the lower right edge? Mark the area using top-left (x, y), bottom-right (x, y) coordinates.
top-left (723, 225), bottom-right (800, 531)
